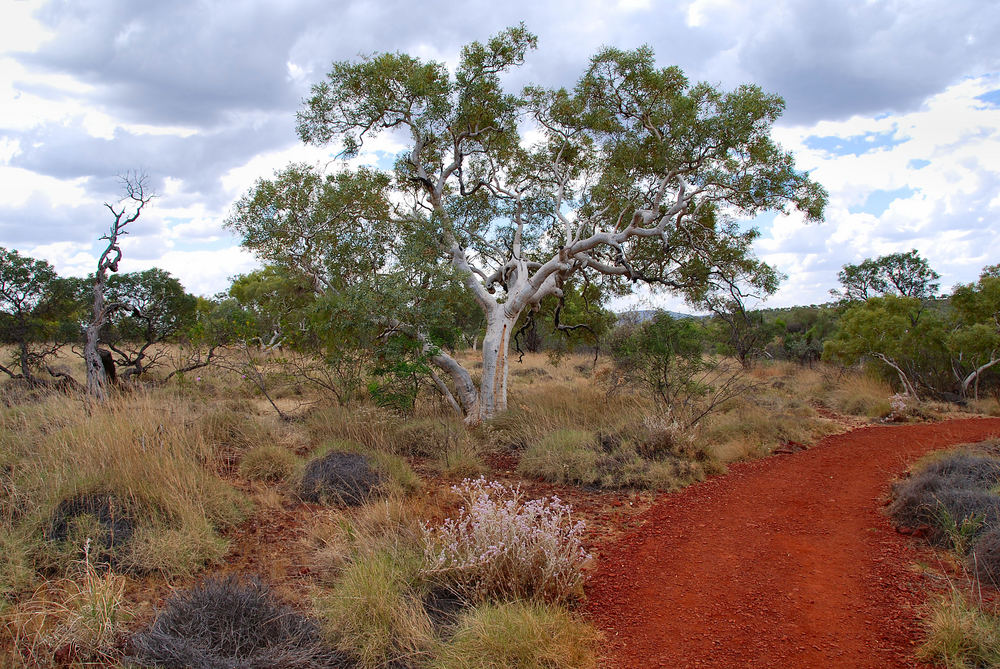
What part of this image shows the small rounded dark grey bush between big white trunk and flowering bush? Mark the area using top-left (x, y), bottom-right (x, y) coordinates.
top-left (299, 451), bottom-right (382, 506)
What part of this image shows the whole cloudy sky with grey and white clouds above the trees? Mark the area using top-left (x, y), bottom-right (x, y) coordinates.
top-left (0, 0), bottom-right (1000, 307)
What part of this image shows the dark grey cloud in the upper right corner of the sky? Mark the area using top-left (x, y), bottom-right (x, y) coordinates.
top-left (739, 0), bottom-right (1000, 123)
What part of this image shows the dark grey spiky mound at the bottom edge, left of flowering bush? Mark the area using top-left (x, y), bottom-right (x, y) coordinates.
top-left (129, 574), bottom-right (350, 669)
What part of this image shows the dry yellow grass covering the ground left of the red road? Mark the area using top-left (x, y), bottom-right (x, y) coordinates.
top-left (0, 344), bottom-right (1000, 667)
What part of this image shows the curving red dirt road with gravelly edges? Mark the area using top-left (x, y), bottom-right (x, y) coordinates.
top-left (587, 419), bottom-right (1000, 668)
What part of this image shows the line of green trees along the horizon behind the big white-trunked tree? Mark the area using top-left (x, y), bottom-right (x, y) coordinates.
top-left (0, 240), bottom-right (1000, 410)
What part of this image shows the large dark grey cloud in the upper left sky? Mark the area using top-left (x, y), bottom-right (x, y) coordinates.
top-left (22, 0), bottom-right (323, 126)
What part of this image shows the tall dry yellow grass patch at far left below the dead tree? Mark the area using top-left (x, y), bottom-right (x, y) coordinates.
top-left (0, 393), bottom-right (246, 588)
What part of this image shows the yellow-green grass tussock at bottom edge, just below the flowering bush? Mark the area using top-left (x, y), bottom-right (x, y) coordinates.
top-left (430, 602), bottom-right (597, 669)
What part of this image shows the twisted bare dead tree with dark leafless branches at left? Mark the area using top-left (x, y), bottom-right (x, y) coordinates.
top-left (83, 172), bottom-right (153, 402)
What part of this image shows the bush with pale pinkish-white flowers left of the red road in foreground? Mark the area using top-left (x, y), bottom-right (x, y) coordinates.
top-left (423, 477), bottom-right (590, 602)
